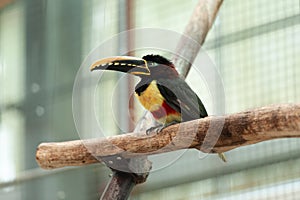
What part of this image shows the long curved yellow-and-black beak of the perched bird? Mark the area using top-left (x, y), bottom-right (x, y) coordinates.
top-left (90, 56), bottom-right (150, 76)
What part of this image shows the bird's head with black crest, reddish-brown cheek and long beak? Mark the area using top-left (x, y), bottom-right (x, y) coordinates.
top-left (90, 55), bottom-right (178, 79)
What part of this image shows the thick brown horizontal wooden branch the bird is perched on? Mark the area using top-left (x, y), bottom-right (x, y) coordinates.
top-left (36, 104), bottom-right (300, 169)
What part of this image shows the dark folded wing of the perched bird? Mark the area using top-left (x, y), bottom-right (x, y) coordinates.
top-left (157, 78), bottom-right (207, 121)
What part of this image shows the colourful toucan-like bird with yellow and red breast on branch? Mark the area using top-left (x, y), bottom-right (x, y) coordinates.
top-left (90, 54), bottom-right (226, 162)
